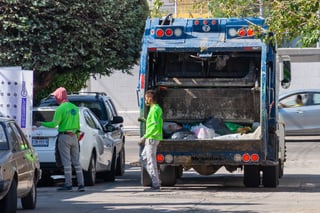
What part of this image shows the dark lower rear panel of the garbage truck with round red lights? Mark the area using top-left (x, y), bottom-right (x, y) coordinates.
top-left (157, 140), bottom-right (278, 167)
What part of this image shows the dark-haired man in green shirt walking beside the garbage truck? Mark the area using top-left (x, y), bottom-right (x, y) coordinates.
top-left (139, 90), bottom-right (163, 191)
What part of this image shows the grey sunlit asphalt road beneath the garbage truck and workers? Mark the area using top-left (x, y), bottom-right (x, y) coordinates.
top-left (18, 136), bottom-right (320, 213)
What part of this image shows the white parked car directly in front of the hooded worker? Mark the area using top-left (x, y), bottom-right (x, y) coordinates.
top-left (32, 106), bottom-right (123, 186)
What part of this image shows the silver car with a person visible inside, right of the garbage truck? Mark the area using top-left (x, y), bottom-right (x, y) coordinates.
top-left (279, 89), bottom-right (320, 136)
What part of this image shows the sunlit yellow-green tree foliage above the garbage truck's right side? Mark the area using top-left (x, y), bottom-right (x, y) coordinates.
top-left (196, 0), bottom-right (320, 47)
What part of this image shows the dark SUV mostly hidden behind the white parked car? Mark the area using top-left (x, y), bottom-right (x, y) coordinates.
top-left (39, 92), bottom-right (125, 176)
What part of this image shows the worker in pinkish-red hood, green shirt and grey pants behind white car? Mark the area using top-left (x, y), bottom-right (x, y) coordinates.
top-left (36, 87), bottom-right (84, 192)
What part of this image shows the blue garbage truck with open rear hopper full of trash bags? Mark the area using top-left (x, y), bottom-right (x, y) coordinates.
top-left (137, 15), bottom-right (290, 187)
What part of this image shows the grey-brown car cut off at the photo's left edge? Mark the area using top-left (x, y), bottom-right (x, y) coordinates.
top-left (0, 117), bottom-right (41, 213)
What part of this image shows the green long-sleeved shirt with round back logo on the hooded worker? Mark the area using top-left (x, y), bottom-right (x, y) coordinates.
top-left (42, 102), bottom-right (80, 133)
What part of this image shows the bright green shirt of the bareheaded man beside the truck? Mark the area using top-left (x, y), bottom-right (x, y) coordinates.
top-left (144, 104), bottom-right (163, 140)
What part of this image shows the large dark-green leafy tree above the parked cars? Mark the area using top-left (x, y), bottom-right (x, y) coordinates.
top-left (0, 0), bottom-right (149, 102)
